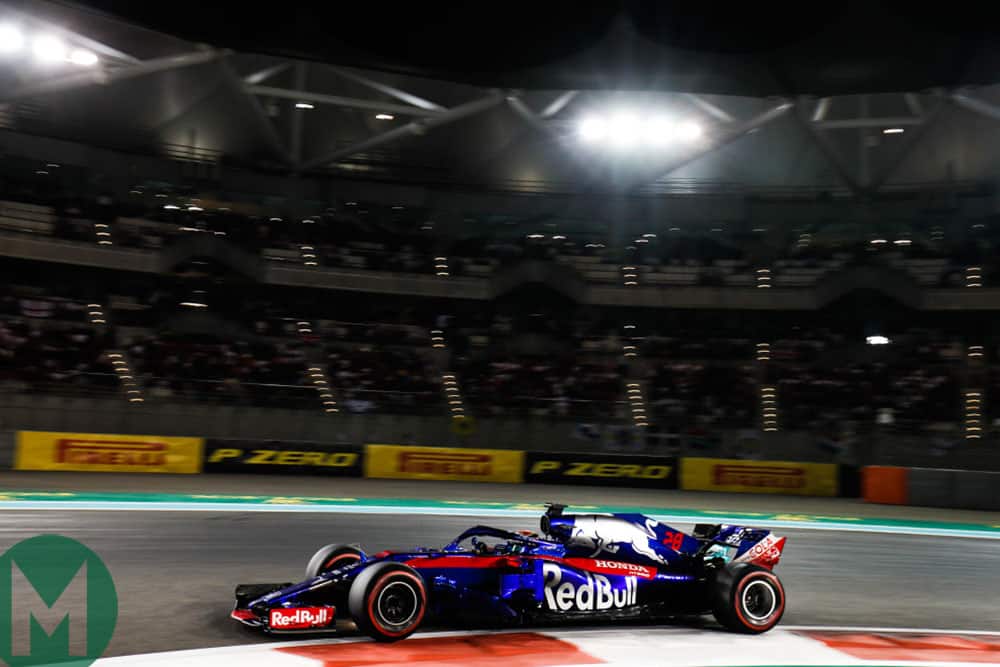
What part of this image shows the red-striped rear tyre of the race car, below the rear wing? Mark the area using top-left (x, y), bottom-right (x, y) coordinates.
top-left (712, 563), bottom-right (785, 634)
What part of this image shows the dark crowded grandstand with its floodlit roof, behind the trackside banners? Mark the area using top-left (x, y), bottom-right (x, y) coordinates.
top-left (0, 1), bottom-right (1000, 474)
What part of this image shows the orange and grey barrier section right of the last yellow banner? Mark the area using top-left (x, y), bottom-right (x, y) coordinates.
top-left (862, 466), bottom-right (1000, 510)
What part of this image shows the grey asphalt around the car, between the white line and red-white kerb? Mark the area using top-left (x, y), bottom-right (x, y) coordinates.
top-left (0, 511), bottom-right (1000, 656)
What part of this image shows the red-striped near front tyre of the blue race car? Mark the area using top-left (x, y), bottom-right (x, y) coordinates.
top-left (347, 563), bottom-right (427, 642)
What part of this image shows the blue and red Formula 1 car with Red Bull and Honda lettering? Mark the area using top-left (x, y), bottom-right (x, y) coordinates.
top-left (231, 505), bottom-right (786, 641)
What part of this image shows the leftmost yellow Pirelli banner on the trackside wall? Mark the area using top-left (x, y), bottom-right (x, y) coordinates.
top-left (14, 431), bottom-right (204, 473)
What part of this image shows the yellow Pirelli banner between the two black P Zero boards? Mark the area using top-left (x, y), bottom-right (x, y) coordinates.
top-left (365, 445), bottom-right (524, 484)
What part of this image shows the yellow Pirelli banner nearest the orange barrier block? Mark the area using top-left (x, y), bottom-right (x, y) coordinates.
top-left (681, 457), bottom-right (837, 496)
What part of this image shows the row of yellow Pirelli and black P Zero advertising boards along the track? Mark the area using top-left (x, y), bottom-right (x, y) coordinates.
top-left (5, 431), bottom-right (868, 502)
